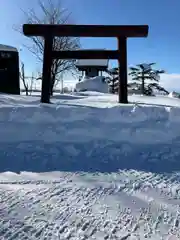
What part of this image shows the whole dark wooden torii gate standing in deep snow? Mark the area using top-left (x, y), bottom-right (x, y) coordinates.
top-left (23, 24), bottom-right (149, 103)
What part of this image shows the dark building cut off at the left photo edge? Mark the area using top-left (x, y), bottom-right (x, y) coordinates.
top-left (0, 44), bottom-right (20, 94)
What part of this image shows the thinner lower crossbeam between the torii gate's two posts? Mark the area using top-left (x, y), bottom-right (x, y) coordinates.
top-left (52, 50), bottom-right (119, 59)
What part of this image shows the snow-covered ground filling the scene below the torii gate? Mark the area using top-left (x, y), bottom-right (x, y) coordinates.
top-left (0, 92), bottom-right (180, 240)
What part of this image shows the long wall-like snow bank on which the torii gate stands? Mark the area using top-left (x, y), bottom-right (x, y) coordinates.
top-left (0, 94), bottom-right (180, 172)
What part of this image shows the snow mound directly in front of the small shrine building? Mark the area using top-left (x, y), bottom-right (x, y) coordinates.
top-left (75, 76), bottom-right (109, 93)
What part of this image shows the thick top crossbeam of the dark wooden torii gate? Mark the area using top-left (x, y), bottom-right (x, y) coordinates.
top-left (23, 24), bottom-right (148, 37)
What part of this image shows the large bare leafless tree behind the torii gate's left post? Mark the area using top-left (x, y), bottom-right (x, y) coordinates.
top-left (21, 0), bottom-right (80, 95)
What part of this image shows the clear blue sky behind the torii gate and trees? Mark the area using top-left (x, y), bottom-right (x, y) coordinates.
top-left (0, 0), bottom-right (180, 89)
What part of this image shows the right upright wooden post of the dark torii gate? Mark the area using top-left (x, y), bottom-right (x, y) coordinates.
top-left (118, 37), bottom-right (128, 103)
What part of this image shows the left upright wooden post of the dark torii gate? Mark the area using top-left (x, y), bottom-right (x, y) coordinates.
top-left (41, 36), bottom-right (53, 103)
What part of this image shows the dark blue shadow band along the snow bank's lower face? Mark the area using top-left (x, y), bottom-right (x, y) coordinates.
top-left (0, 140), bottom-right (180, 173)
